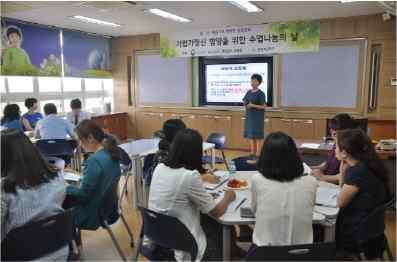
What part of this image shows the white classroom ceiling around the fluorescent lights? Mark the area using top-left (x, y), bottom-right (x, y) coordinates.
top-left (1, 1), bottom-right (384, 36)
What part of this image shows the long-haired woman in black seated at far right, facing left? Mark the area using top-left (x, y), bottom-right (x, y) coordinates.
top-left (336, 129), bottom-right (389, 256)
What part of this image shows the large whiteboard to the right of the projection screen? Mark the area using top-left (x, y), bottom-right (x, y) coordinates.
top-left (281, 40), bottom-right (365, 108)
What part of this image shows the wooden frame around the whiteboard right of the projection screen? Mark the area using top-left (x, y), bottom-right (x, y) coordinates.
top-left (276, 38), bottom-right (368, 114)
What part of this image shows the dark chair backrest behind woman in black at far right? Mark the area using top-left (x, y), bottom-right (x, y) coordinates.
top-left (356, 195), bottom-right (396, 244)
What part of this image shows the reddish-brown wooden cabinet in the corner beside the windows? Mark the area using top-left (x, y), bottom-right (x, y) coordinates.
top-left (92, 113), bottom-right (128, 140)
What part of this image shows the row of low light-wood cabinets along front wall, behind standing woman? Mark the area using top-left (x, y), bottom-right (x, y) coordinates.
top-left (136, 110), bottom-right (326, 150)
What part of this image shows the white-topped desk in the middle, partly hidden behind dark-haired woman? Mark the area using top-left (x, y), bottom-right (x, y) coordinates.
top-left (120, 138), bottom-right (215, 168)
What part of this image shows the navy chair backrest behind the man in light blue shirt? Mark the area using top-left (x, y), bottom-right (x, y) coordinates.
top-left (36, 139), bottom-right (77, 156)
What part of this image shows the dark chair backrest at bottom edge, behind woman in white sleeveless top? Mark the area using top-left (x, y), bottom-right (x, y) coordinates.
top-left (245, 242), bottom-right (336, 261)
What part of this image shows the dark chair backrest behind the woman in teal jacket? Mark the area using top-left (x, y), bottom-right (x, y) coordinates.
top-left (98, 177), bottom-right (120, 226)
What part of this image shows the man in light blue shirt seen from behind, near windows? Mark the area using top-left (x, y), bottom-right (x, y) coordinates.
top-left (34, 103), bottom-right (76, 139)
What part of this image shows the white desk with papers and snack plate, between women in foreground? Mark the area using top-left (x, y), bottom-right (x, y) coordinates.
top-left (208, 171), bottom-right (339, 261)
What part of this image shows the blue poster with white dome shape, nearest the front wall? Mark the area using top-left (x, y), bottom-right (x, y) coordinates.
top-left (63, 30), bottom-right (111, 77)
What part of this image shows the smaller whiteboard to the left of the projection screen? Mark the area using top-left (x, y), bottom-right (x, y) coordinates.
top-left (135, 52), bottom-right (192, 106)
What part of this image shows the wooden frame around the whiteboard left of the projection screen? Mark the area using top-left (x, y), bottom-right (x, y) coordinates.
top-left (133, 49), bottom-right (193, 108)
